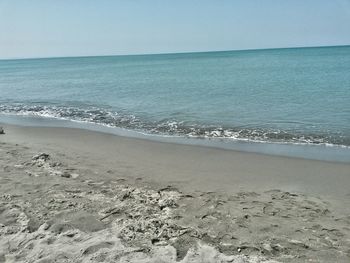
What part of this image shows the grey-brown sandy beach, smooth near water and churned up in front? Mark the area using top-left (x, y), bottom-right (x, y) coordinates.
top-left (0, 124), bottom-right (350, 263)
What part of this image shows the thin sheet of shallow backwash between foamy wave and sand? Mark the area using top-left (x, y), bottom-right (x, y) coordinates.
top-left (0, 114), bottom-right (350, 164)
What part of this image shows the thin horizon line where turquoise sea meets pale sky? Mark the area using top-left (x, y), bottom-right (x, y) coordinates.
top-left (0, 44), bottom-right (350, 61)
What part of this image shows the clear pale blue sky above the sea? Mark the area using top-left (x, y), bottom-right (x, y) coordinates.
top-left (0, 0), bottom-right (350, 58)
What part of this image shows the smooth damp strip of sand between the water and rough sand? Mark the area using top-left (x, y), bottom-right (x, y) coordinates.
top-left (0, 124), bottom-right (350, 201)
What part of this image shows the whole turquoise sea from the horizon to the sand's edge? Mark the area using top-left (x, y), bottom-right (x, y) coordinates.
top-left (0, 46), bottom-right (350, 162)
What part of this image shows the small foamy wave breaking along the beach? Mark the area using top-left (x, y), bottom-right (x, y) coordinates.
top-left (0, 103), bottom-right (350, 147)
